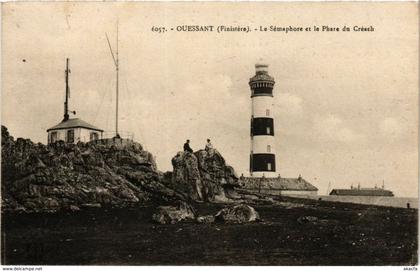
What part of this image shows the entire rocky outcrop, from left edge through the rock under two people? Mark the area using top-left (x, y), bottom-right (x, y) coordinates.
top-left (1, 126), bottom-right (243, 212)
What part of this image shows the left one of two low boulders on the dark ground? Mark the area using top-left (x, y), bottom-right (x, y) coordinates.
top-left (152, 202), bottom-right (195, 224)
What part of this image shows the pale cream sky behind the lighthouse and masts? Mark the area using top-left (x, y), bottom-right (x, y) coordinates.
top-left (1, 2), bottom-right (419, 197)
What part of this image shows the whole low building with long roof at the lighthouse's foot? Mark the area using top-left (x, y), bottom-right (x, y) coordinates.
top-left (239, 176), bottom-right (318, 195)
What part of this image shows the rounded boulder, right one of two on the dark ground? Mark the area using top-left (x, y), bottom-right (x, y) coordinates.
top-left (215, 204), bottom-right (260, 223)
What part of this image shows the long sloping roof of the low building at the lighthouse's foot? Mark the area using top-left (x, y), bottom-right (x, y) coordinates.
top-left (240, 177), bottom-right (318, 191)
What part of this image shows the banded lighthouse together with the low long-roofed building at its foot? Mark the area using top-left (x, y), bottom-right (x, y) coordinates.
top-left (240, 63), bottom-right (318, 195)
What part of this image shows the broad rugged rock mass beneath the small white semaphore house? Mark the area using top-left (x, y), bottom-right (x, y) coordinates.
top-left (1, 126), bottom-right (186, 212)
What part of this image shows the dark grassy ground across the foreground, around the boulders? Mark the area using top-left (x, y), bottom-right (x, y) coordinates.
top-left (2, 199), bottom-right (418, 265)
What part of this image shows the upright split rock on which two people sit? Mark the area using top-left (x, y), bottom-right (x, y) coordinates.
top-left (171, 149), bottom-right (238, 201)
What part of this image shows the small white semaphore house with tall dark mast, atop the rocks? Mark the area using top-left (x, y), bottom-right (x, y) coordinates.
top-left (47, 59), bottom-right (104, 144)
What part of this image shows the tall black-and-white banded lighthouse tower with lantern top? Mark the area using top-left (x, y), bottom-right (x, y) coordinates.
top-left (249, 63), bottom-right (278, 177)
